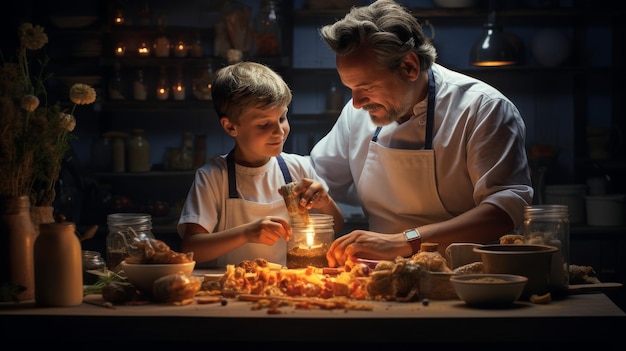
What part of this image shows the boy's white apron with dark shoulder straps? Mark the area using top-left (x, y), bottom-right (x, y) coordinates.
top-left (216, 151), bottom-right (291, 267)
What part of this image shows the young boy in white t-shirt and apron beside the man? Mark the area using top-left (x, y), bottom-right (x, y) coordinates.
top-left (178, 62), bottom-right (343, 267)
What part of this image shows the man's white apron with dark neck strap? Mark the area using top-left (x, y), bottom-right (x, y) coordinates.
top-left (357, 69), bottom-right (453, 233)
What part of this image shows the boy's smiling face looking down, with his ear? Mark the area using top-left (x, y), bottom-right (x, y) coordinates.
top-left (221, 107), bottom-right (291, 167)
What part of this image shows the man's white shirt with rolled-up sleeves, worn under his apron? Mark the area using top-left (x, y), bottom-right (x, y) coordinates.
top-left (310, 64), bottom-right (533, 227)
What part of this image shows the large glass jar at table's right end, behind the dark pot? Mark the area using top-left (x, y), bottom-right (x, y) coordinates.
top-left (524, 205), bottom-right (570, 293)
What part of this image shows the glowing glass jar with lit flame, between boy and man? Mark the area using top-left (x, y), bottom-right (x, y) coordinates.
top-left (287, 214), bottom-right (335, 268)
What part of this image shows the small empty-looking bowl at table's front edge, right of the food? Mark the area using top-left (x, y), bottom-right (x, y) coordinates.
top-left (450, 274), bottom-right (528, 307)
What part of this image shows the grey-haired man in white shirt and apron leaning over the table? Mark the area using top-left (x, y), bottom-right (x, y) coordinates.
top-left (311, 0), bottom-right (533, 266)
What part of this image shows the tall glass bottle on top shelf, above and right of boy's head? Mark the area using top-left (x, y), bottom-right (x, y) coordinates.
top-left (254, 0), bottom-right (282, 56)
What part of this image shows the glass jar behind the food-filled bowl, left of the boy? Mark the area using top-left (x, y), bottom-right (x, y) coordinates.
top-left (106, 213), bottom-right (154, 272)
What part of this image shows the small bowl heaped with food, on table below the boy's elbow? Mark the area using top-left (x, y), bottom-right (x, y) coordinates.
top-left (121, 261), bottom-right (196, 295)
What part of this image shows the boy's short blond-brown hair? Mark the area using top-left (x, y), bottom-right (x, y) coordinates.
top-left (211, 62), bottom-right (292, 123)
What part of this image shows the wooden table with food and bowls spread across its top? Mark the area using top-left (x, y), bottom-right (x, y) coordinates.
top-left (0, 293), bottom-right (626, 350)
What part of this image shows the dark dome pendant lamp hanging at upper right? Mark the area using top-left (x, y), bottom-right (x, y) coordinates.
top-left (470, 0), bottom-right (522, 67)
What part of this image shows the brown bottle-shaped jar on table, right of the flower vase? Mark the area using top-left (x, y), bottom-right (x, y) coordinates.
top-left (34, 222), bottom-right (83, 307)
